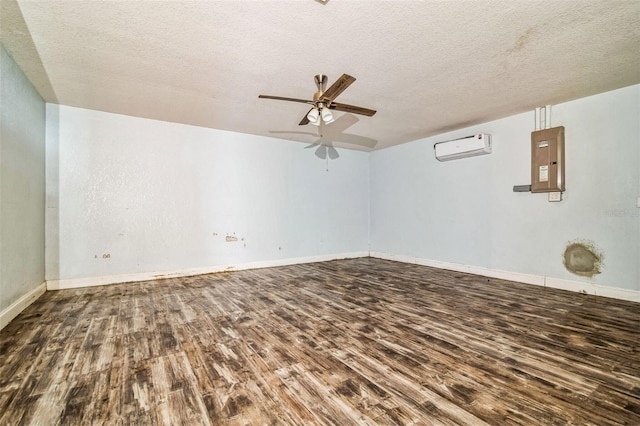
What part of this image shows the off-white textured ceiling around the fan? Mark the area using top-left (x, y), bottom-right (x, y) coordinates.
top-left (0, 0), bottom-right (640, 150)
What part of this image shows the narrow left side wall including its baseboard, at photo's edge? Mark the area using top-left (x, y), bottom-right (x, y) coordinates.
top-left (0, 45), bottom-right (45, 322)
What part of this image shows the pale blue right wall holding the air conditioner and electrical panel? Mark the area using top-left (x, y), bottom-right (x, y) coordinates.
top-left (370, 86), bottom-right (640, 291)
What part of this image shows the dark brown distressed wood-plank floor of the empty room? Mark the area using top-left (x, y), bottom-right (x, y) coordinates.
top-left (0, 258), bottom-right (640, 425)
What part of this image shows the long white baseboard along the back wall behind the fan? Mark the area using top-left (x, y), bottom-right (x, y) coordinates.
top-left (47, 251), bottom-right (369, 290)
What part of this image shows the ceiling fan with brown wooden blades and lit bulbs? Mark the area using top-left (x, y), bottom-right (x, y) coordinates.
top-left (258, 74), bottom-right (376, 126)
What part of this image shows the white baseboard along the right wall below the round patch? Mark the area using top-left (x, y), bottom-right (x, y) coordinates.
top-left (370, 252), bottom-right (640, 302)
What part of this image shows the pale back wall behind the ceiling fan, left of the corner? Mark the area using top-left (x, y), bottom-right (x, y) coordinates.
top-left (47, 104), bottom-right (369, 286)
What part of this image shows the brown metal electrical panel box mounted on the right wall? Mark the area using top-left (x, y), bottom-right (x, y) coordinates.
top-left (531, 126), bottom-right (565, 192)
